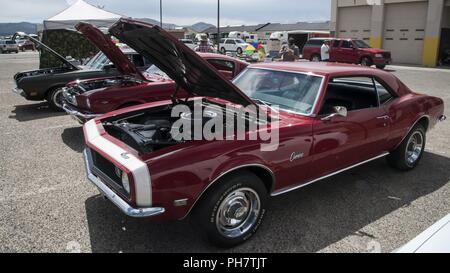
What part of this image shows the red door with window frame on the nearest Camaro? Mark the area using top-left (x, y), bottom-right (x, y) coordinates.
top-left (312, 77), bottom-right (390, 177)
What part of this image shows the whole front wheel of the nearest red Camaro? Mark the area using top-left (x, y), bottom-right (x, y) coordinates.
top-left (194, 171), bottom-right (268, 248)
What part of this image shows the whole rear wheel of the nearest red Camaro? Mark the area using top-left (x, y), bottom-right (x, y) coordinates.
top-left (387, 124), bottom-right (426, 171)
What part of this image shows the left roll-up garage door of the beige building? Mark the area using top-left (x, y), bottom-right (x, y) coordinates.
top-left (337, 6), bottom-right (372, 42)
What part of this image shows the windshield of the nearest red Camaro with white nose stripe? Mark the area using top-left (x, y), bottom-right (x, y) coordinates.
top-left (233, 68), bottom-right (323, 115)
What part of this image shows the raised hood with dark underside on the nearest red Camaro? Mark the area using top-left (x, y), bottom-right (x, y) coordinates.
top-left (109, 18), bottom-right (254, 106)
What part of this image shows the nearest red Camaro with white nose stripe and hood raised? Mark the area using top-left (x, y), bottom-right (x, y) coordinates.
top-left (84, 19), bottom-right (445, 247)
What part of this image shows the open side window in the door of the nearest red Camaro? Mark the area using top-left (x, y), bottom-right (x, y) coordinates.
top-left (320, 77), bottom-right (378, 115)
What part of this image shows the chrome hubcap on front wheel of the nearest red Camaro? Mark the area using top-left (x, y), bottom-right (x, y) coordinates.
top-left (216, 188), bottom-right (261, 238)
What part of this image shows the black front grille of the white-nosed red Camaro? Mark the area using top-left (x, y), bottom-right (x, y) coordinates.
top-left (90, 150), bottom-right (129, 197)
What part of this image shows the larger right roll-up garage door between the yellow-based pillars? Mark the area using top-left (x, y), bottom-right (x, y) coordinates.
top-left (383, 2), bottom-right (428, 64)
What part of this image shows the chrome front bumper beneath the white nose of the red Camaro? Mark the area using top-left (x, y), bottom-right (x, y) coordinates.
top-left (83, 150), bottom-right (165, 218)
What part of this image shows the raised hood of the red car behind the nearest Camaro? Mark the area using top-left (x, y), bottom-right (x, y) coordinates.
top-left (75, 22), bottom-right (146, 80)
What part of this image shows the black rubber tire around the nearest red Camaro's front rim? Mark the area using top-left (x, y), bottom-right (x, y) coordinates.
top-left (193, 171), bottom-right (268, 248)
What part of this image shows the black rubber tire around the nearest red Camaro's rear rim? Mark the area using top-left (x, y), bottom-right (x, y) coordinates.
top-left (387, 124), bottom-right (427, 171)
